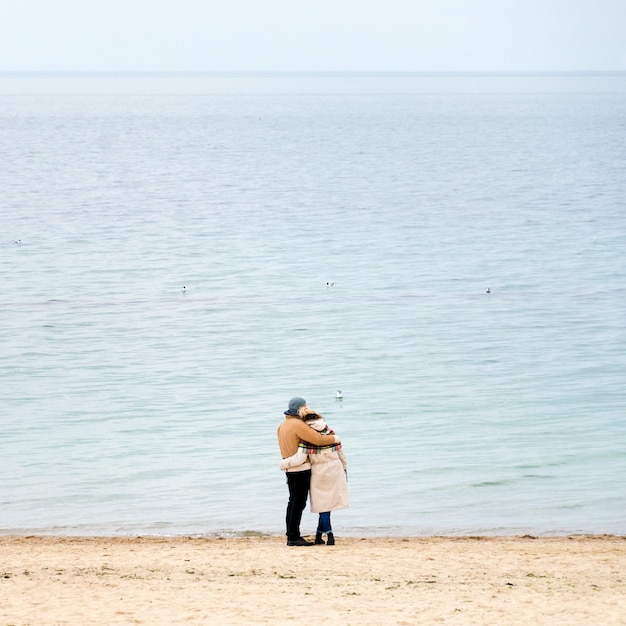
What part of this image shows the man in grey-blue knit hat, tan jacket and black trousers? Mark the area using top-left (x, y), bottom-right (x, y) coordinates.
top-left (278, 397), bottom-right (340, 546)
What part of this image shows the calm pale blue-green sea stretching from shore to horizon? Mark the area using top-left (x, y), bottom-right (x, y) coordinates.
top-left (0, 73), bottom-right (626, 537)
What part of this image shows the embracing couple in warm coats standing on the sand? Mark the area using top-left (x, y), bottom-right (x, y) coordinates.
top-left (278, 397), bottom-right (350, 546)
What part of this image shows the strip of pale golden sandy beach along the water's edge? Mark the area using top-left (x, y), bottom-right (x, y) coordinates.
top-left (0, 536), bottom-right (626, 626)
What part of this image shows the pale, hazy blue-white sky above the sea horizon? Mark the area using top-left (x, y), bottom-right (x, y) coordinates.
top-left (0, 0), bottom-right (626, 72)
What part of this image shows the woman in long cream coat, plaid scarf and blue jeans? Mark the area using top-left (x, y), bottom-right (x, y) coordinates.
top-left (280, 405), bottom-right (350, 546)
